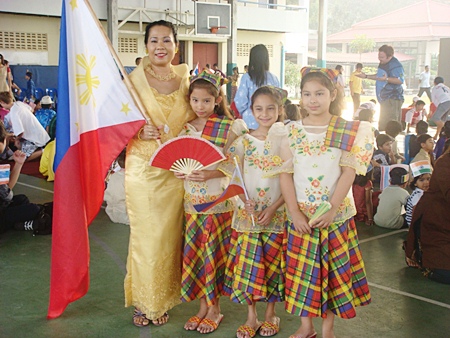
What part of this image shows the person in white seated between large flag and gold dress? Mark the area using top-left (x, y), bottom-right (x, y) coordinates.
top-left (104, 149), bottom-right (130, 224)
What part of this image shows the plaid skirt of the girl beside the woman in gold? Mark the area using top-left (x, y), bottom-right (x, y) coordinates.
top-left (181, 211), bottom-right (233, 306)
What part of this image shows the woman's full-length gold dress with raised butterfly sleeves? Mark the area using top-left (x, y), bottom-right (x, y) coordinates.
top-left (124, 57), bottom-right (195, 320)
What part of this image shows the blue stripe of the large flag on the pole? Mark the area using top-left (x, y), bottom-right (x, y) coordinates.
top-left (53, 1), bottom-right (70, 172)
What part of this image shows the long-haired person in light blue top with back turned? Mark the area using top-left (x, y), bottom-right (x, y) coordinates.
top-left (234, 44), bottom-right (280, 130)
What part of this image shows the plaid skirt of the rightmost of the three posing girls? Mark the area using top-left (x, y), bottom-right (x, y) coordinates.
top-left (283, 218), bottom-right (371, 318)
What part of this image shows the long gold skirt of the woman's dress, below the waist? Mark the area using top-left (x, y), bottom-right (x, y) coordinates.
top-left (125, 153), bottom-right (184, 320)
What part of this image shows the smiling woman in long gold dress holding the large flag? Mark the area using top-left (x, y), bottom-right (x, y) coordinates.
top-left (125, 20), bottom-right (195, 326)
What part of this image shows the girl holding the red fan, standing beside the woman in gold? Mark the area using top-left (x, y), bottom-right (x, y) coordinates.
top-left (175, 71), bottom-right (246, 333)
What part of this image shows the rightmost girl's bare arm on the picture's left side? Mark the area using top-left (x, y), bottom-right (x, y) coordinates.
top-left (280, 173), bottom-right (311, 234)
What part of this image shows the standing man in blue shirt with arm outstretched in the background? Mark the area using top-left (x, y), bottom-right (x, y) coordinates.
top-left (357, 45), bottom-right (405, 131)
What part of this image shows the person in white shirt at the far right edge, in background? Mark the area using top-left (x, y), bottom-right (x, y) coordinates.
top-left (430, 76), bottom-right (450, 140)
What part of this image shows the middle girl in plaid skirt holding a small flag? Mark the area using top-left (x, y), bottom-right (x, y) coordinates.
top-left (219, 86), bottom-right (287, 338)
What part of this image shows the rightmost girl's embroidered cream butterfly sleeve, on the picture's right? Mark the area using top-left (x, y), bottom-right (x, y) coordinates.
top-left (340, 121), bottom-right (374, 175)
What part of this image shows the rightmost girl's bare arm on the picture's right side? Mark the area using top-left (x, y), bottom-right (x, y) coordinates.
top-left (310, 166), bottom-right (356, 228)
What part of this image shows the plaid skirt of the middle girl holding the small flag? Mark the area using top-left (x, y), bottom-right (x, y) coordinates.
top-left (225, 230), bottom-right (284, 304)
